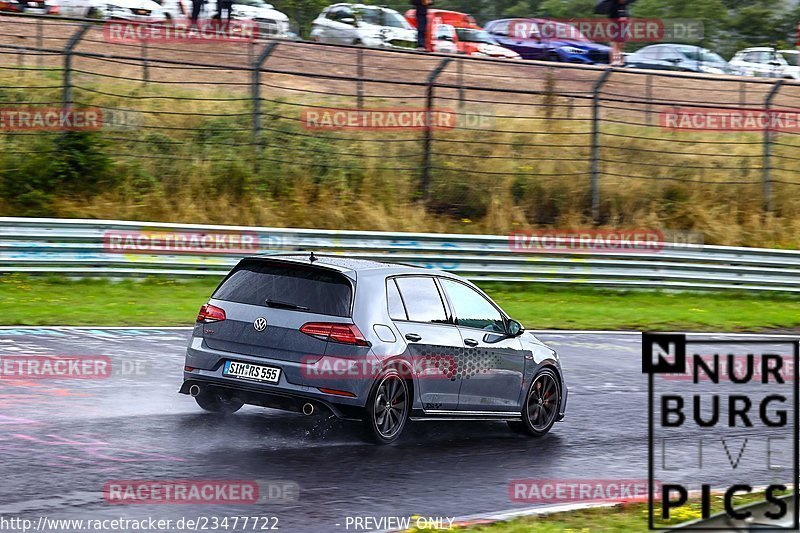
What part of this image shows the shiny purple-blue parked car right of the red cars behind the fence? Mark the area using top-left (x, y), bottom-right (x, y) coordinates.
top-left (485, 19), bottom-right (611, 65)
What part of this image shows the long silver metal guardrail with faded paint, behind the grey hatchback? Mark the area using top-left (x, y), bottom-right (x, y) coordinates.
top-left (0, 217), bottom-right (800, 292)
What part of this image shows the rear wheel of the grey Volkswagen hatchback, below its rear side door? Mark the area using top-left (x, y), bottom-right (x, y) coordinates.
top-left (364, 369), bottom-right (411, 444)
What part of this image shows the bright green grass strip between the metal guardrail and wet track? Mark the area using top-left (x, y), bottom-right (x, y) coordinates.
top-left (0, 275), bottom-right (800, 331)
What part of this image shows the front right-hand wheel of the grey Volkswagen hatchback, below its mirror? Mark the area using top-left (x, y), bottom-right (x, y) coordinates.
top-left (508, 368), bottom-right (561, 437)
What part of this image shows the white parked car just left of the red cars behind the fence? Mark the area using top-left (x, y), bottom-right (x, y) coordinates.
top-left (311, 3), bottom-right (417, 49)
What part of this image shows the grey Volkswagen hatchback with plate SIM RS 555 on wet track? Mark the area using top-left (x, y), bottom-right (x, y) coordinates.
top-left (180, 253), bottom-right (567, 444)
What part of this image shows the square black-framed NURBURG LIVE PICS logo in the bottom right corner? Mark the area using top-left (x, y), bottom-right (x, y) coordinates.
top-left (642, 333), bottom-right (800, 531)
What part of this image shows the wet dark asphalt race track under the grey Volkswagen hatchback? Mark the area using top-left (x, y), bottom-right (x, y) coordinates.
top-left (0, 328), bottom-right (792, 531)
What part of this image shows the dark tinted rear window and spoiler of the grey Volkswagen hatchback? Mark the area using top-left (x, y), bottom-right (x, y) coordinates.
top-left (212, 261), bottom-right (353, 317)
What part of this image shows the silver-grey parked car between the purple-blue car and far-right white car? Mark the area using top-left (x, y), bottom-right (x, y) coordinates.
top-left (625, 44), bottom-right (744, 75)
